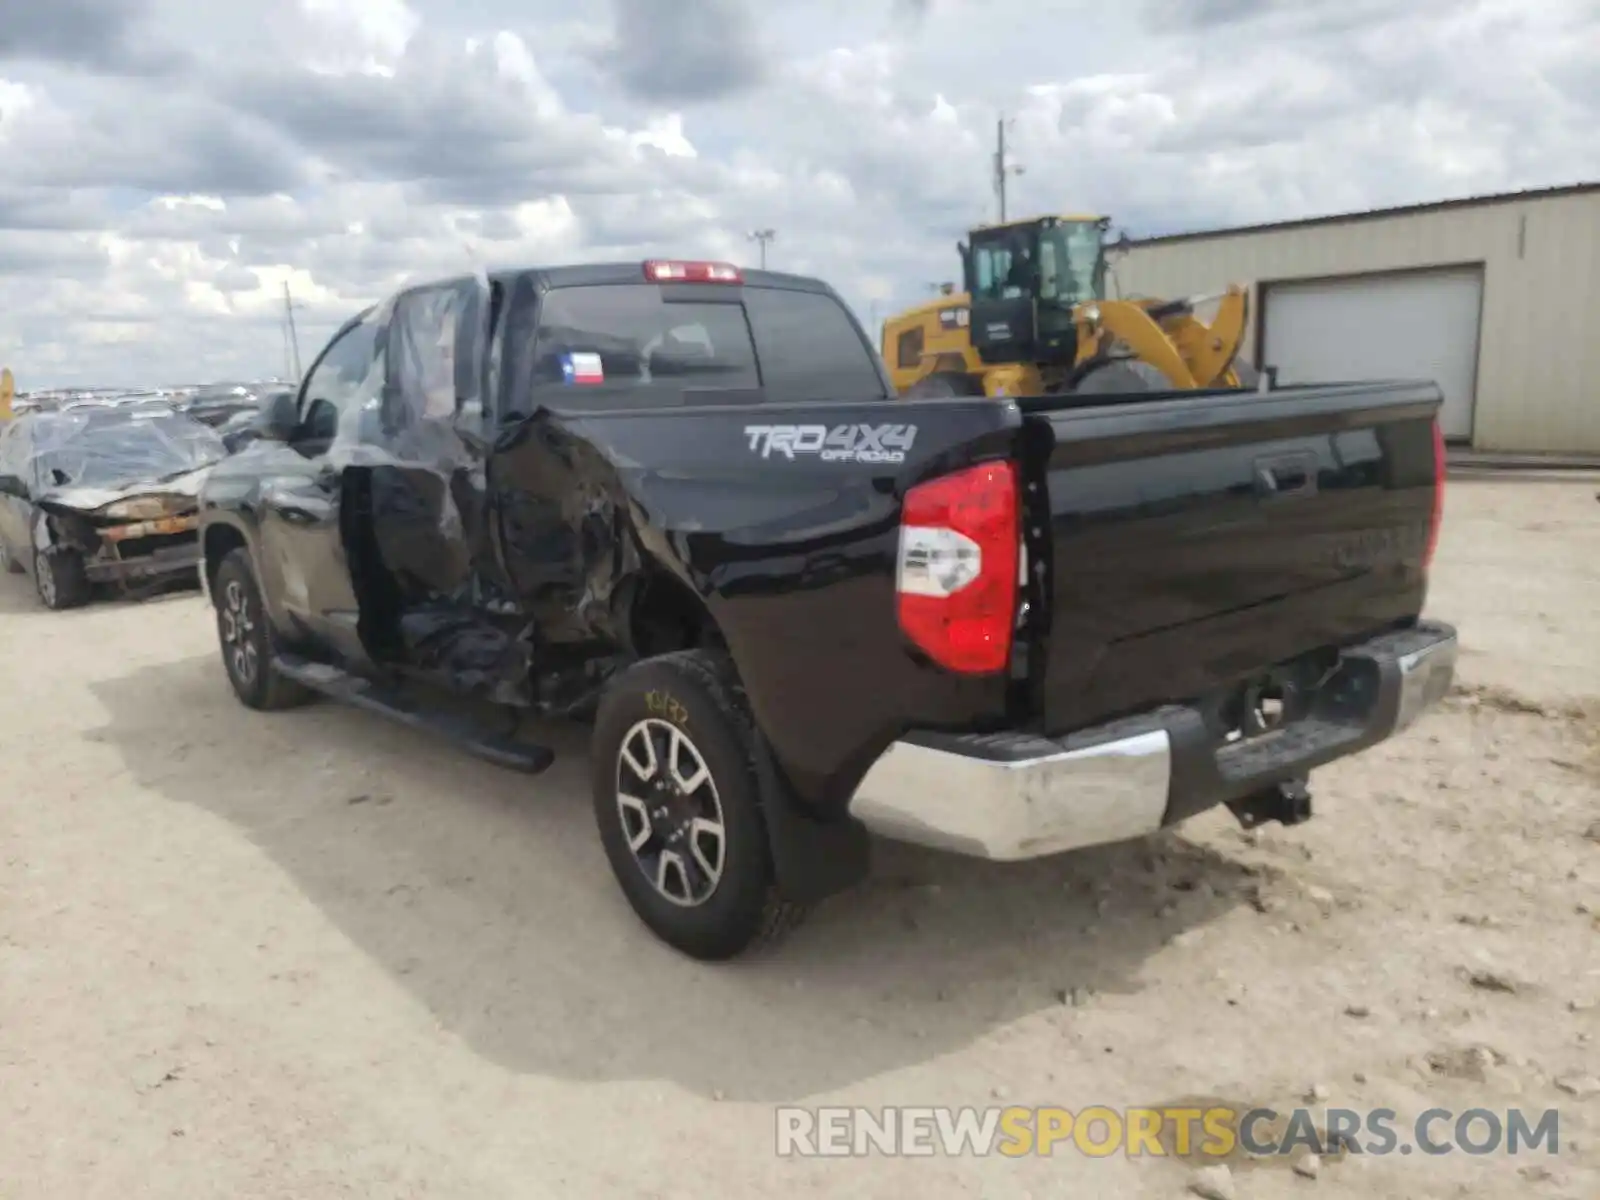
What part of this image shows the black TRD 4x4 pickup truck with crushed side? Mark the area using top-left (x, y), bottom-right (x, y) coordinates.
top-left (202, 261), bottom-right (1456, 958)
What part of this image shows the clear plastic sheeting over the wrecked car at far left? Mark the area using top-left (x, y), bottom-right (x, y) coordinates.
top-left (30, 410), bottom-right (227, 507)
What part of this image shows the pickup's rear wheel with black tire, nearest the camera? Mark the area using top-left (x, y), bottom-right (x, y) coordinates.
top-left (589, 650), bottom-right (805, 962)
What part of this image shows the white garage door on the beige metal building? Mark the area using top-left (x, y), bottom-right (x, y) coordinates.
top-left (1261, 267), bottom-right (1483, 438)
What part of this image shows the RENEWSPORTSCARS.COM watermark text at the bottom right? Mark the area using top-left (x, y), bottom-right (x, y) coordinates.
top-left (776, 1106), bottom-right (1560, 1158)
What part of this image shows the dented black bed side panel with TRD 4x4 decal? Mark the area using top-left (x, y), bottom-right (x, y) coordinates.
top-left (493, 402), bottom-right (1016, 810)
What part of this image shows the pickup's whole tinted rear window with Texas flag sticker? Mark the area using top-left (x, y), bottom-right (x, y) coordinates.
top-left (531, 285), bottom-right (888, 406)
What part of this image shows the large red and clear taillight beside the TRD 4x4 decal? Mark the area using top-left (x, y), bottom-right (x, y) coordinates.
top-left (894, 462), bottom-right (1019, 675)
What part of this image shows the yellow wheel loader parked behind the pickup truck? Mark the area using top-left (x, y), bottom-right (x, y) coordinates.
top-left (883, 216), bottom-right (1256, 395)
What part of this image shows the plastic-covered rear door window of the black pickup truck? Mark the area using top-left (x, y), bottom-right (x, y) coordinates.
top-left (389, 280), bottom-right (477, 421)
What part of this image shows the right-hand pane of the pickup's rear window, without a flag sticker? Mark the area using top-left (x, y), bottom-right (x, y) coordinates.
top-left (744, 286), bottom-right (888, 403)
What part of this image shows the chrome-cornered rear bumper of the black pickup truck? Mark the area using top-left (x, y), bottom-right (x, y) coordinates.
top-left (850, 622), bottom-right (1456, 861)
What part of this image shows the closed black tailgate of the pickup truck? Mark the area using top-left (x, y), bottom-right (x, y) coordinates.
top-left (1021, 382), bottom-right (1442, 733)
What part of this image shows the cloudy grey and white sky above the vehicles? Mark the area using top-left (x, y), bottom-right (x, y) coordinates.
top-left (0, 0), bottom-right (1600, 389)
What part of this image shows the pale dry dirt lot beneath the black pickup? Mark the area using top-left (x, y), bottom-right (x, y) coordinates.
top-left (0, 480), bottom-right (1600, 1200)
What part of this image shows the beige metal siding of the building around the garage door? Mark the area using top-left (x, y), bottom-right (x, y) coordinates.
top-left (1115, 192), bottom-right (1600, 453)
